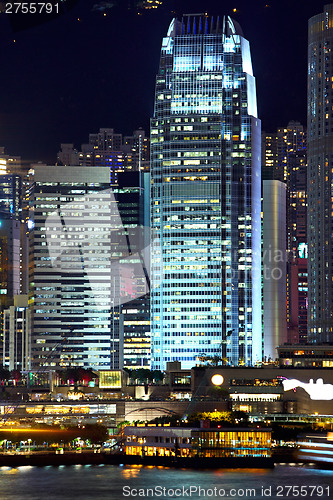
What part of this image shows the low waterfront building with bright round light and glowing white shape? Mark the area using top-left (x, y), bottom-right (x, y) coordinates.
top-left (191, 366), bottom-right (333, 416)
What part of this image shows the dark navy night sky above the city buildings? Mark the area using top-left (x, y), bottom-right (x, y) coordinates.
top-left (0, 0), bottom-right (329, 163)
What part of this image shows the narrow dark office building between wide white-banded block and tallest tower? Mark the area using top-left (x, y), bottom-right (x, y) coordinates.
top-left (113, 171), bottom-right (150, 369)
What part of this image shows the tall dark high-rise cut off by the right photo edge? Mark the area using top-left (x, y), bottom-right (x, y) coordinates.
top-left (307, 4), bottom-right (333, 343)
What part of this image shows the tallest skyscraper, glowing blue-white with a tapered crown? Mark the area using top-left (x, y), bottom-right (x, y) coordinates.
top-left (151, 15), bottom-right (262, 369)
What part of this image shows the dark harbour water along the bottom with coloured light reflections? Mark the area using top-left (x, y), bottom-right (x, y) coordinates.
top-left (0, 465), bottom-right (333, 500)
